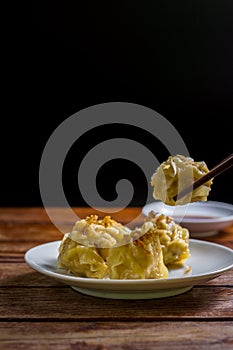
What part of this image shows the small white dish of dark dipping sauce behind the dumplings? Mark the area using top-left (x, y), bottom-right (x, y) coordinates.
top-left (142, 201), bottom-right (233, 237)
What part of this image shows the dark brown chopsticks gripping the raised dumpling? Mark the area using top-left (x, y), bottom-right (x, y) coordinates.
top-left (174, 153), bottom-right (233, 200)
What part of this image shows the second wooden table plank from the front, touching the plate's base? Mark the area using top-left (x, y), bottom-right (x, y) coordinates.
top-left (0, 286), bottom-right (233, 321)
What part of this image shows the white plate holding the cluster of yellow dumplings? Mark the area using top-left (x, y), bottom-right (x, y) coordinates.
top-left (25, 239), bottom-right (233, 299)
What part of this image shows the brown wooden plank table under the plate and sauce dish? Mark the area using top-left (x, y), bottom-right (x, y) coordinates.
top-left (0, 208), bottom-right (233, 350)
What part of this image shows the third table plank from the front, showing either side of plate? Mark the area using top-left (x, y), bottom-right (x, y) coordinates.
top-left (0, 262), bottom-right (233, 287)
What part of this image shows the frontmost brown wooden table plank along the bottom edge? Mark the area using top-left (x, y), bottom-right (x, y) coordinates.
top-left (0, 321), bottom-right (233, 350)
